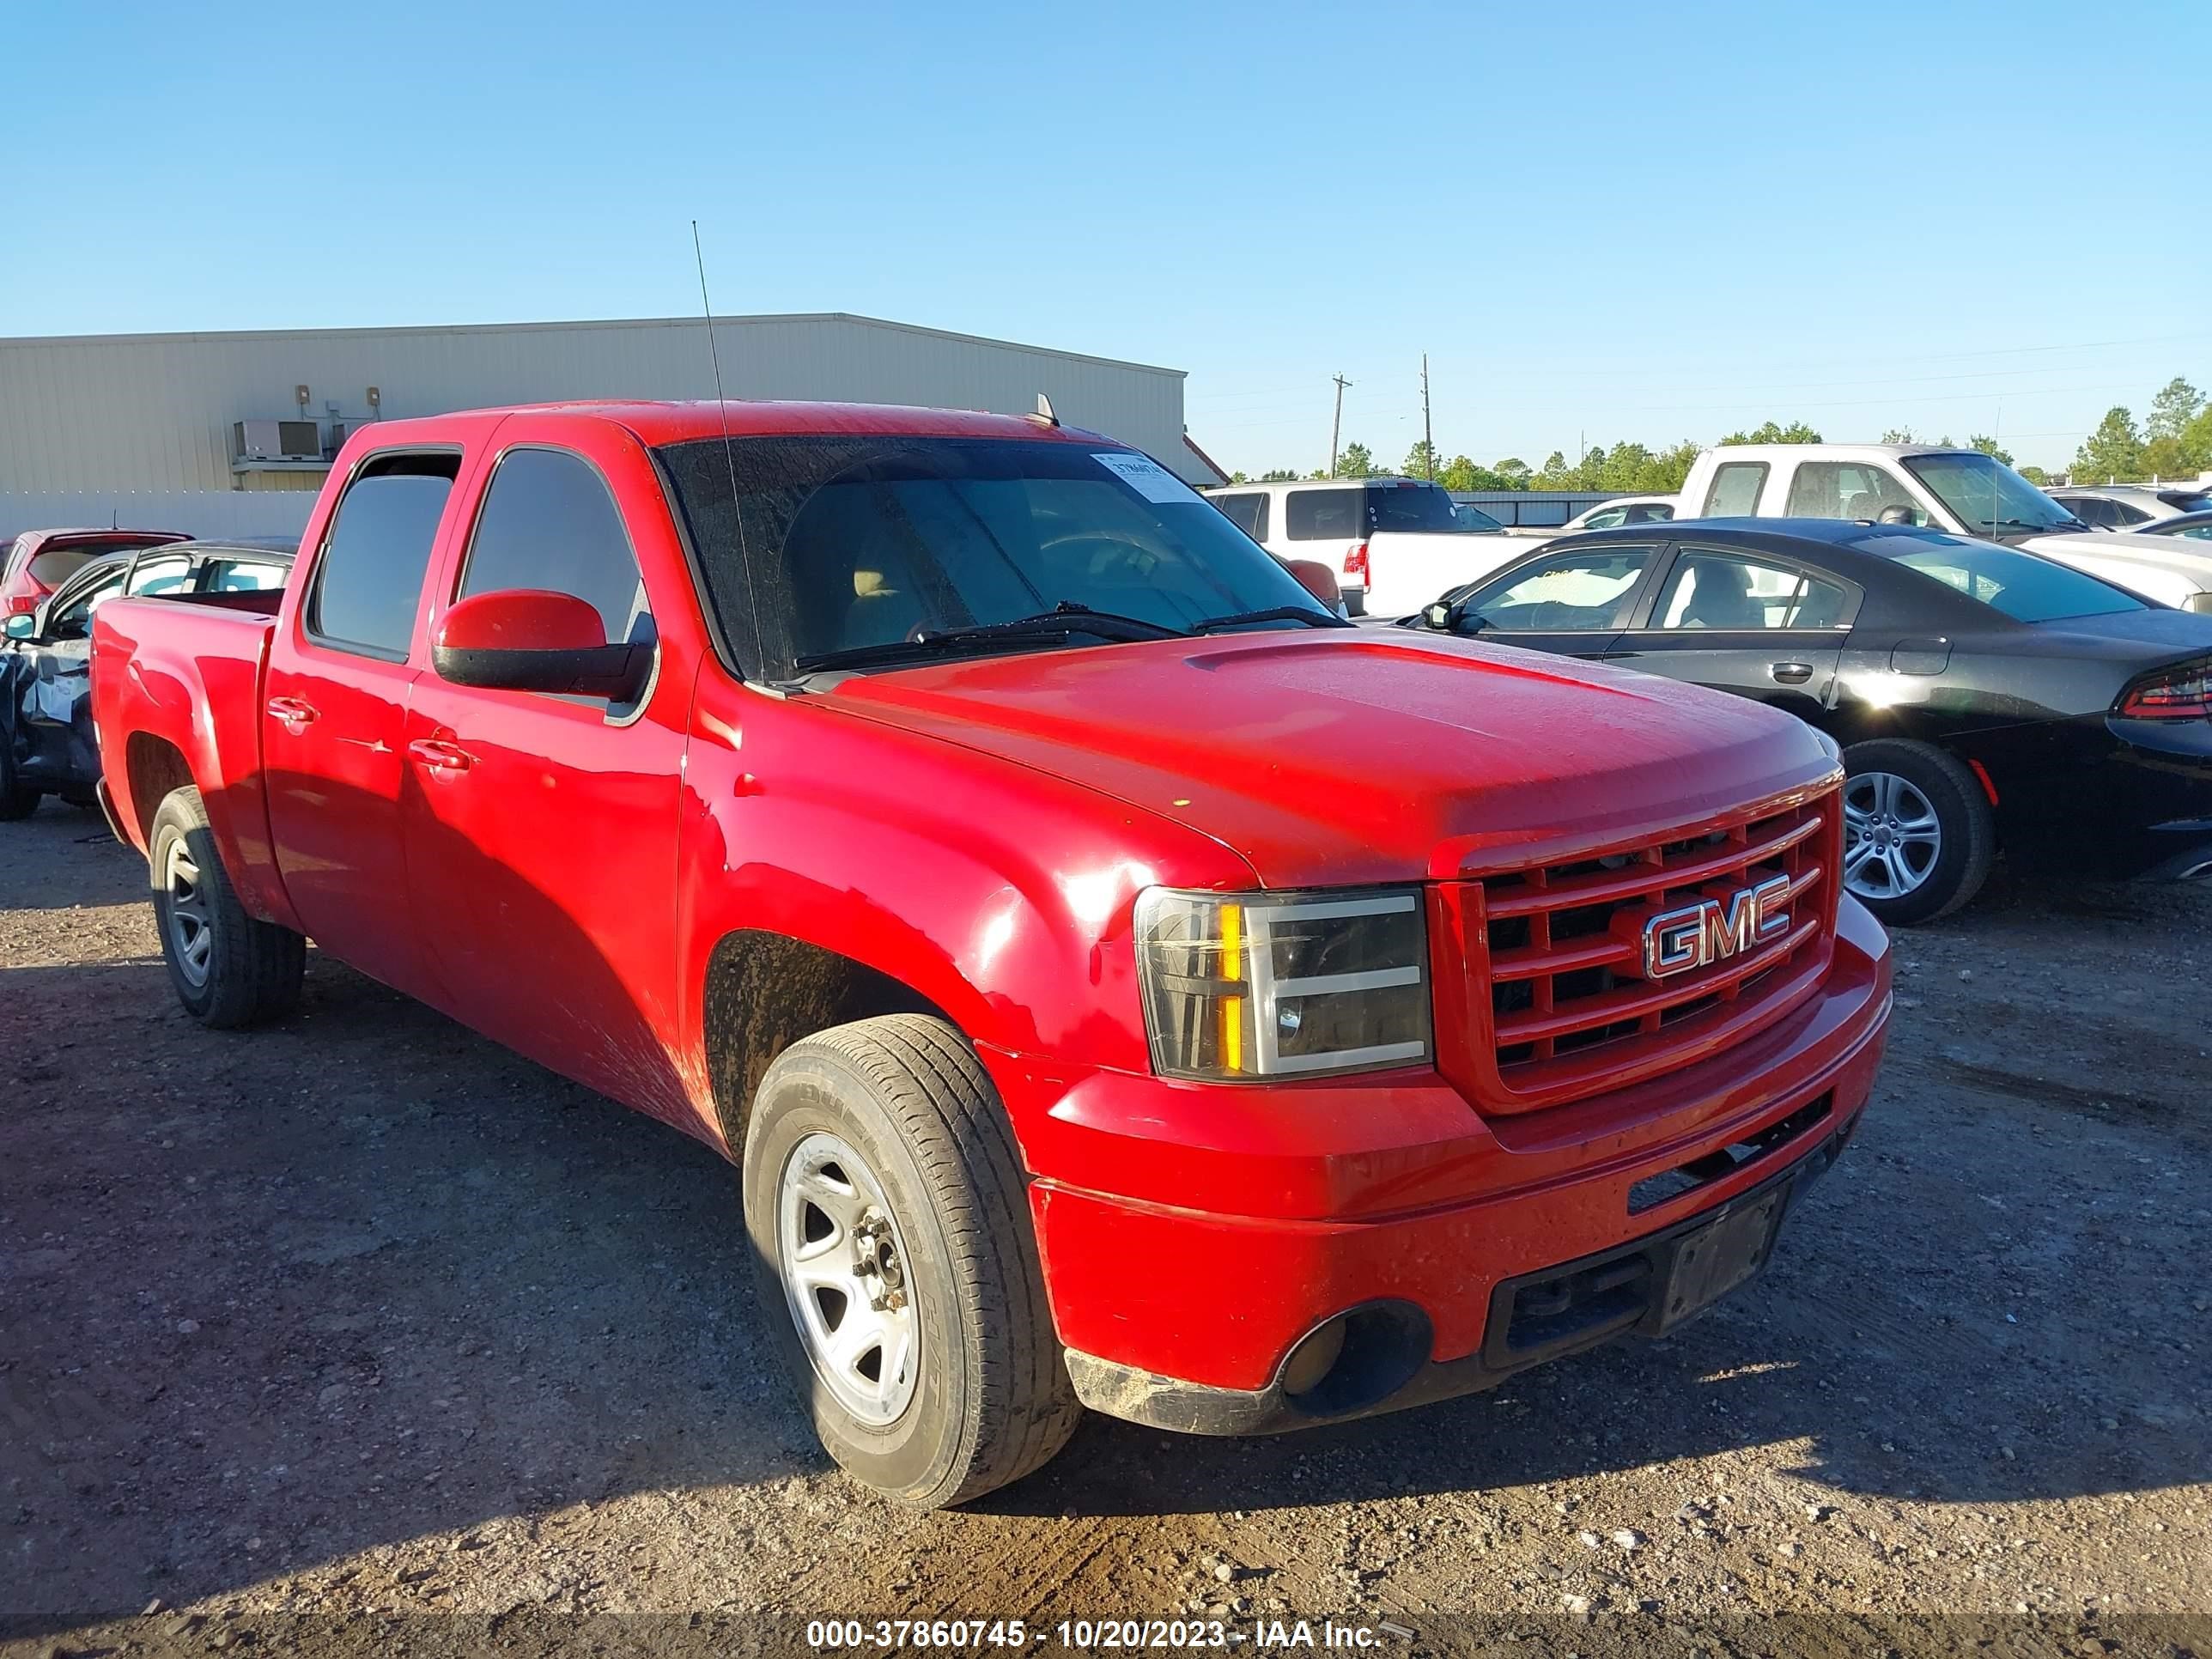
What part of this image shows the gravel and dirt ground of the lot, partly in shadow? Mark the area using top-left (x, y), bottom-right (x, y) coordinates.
top-left (0, 803), bottom-right (2212, 1655)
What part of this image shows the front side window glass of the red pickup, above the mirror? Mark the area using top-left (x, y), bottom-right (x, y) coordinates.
top-left (456, 449), bottom-right (653, 644)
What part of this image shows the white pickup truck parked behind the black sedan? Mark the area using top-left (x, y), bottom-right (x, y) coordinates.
top-left (1677, 445), bottom-right (2212, 613)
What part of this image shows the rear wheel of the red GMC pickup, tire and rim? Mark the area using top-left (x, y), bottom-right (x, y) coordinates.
top-left (146, 785), bottom-right (307, 1030)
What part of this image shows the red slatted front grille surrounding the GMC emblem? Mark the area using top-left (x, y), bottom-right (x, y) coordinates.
top-left (1462, 790), bottom-right (1840, 1113)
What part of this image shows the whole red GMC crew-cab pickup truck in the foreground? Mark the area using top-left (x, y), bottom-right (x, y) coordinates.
top-left (93, 403), bottom-right (1891, 1504)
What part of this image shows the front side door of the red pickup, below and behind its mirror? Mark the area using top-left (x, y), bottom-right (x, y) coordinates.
top-left (404, 428), bottom-right (695, 1126)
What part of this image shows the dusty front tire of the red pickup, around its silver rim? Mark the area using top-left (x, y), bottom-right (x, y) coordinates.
top-left (744, 1013), bottom-right (1082, 1509)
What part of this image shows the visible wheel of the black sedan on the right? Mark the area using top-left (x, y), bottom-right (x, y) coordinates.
top-left (1843, 737), bottom-right (1997, 927)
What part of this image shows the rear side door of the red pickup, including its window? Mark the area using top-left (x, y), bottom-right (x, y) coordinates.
top-left (261, 447), bottom-right (460, 1002)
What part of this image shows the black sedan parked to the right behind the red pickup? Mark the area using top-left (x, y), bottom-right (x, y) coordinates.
top-left (1401, 518), bottom-right (2212, 922)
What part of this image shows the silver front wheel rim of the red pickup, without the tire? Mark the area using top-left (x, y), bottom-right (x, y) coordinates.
top-left (776, 1130), bottom-right (922, 1427)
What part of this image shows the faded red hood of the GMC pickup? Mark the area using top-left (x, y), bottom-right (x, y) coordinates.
top-left (823, 629), bottom-right (1838, 887)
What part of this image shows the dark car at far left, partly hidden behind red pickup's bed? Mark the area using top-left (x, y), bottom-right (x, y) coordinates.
top-left (0, 542), bottom-right (296, 821)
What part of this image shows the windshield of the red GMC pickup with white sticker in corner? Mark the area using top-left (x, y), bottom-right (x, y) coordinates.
top-left (659, 434), bottom-right (1336, 679)
